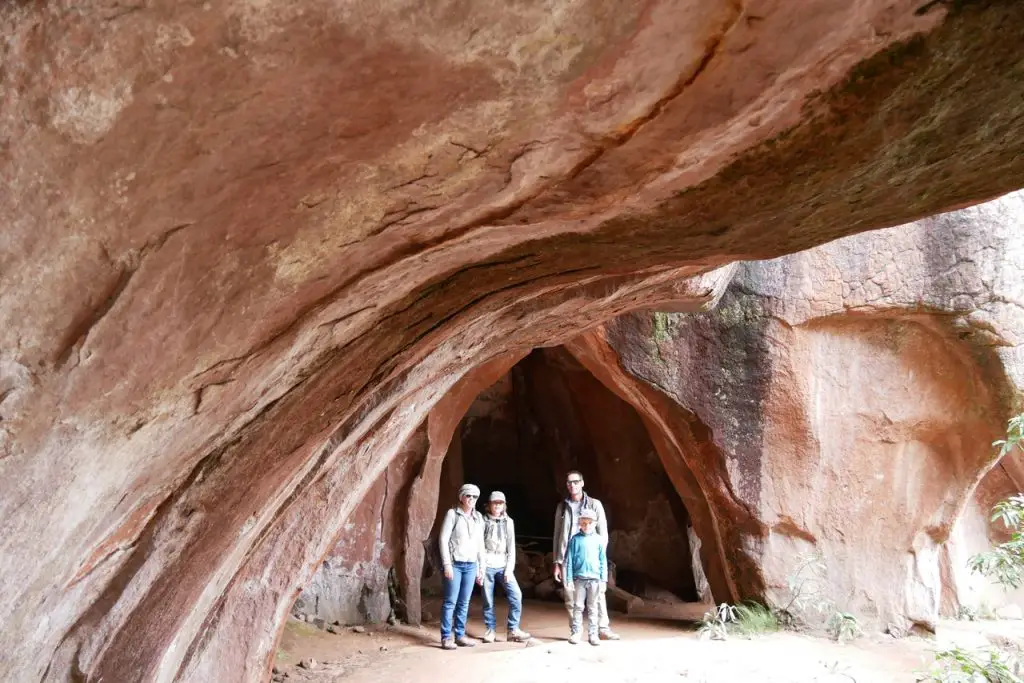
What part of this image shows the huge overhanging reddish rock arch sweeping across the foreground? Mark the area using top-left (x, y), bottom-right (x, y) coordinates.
top-left (0, 0), bottom-right (1024, 681)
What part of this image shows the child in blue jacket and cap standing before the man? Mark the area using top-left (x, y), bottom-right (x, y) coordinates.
top-left (565, 509), bottom-right (608, 645)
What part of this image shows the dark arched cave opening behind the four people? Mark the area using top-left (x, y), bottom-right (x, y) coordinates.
top-left (434, 347), bottom-right (698, 601)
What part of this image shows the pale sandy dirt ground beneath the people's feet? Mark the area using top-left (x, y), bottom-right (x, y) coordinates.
top-left (275, 600), bottom-right (1024, 683)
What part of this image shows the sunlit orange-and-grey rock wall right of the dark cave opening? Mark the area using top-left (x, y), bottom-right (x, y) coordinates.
top-left (598, 194), bottom-right (1024, 628)
